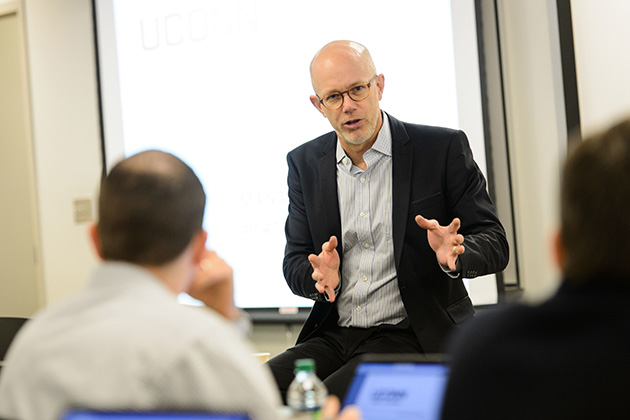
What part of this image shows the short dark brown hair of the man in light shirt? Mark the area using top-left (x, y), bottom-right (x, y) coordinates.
top-left (98, 150), bottom-right (206, 265)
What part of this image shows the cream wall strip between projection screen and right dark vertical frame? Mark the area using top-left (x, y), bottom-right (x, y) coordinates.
top-left (497, 0), bottom-right (567, 301)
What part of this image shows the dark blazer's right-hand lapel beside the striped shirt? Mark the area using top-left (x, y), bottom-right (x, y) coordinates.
top-left (387, 114), bottom-right (413, 267)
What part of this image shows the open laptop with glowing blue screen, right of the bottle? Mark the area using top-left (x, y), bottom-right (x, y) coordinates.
top-left (343, 354), bottom-right (449, 420)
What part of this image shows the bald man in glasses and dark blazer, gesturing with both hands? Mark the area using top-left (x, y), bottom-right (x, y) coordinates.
top-left (268, 41), bottom-right (509, 396)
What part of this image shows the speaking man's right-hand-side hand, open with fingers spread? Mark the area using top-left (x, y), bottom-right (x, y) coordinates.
top-left (416, 215), bottom-right (466, 271)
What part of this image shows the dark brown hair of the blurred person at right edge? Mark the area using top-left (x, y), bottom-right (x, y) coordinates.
top-left (560, 119), bottom-right (630, 282)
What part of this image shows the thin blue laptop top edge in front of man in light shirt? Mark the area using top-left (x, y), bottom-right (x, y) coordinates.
top-left (60, 410), bottom-right (251, 420)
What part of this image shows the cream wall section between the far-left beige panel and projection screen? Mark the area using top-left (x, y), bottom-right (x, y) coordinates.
top-left (24, 0), bottom-right (101, 303)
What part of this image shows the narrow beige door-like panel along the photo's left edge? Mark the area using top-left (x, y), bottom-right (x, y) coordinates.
top-left (0, 1), bottom-right (43, 317)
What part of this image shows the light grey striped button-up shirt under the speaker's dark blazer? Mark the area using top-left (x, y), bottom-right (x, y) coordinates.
top-left (337, 113), bottom-right (407, 328)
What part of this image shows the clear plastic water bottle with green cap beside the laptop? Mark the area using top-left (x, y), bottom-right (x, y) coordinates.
top-left (287, 359), bottom-right (328, 420)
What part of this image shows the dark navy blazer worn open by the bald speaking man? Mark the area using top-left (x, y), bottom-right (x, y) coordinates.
top-left (283, 115), bottom-right (509, 353)
